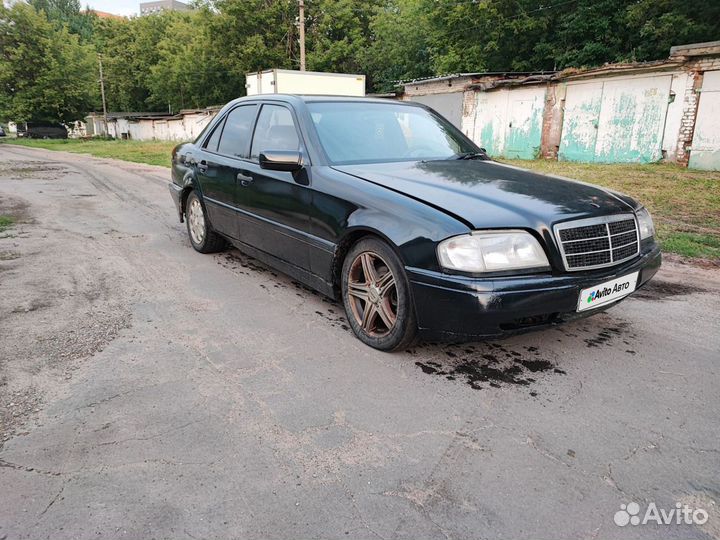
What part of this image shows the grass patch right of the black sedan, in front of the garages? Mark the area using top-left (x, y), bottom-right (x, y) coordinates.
top-left (502, 160), bottom-right (720, 260)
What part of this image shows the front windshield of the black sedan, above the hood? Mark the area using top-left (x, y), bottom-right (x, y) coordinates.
top-left (308, 102), bottom-right (479, 165)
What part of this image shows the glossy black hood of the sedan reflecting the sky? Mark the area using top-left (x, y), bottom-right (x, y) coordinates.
top-left (334, 160), bottom-right (635, 230)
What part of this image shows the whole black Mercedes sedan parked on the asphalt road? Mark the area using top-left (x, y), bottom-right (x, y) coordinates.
top-left (170, 94), bottom-right (660, 350)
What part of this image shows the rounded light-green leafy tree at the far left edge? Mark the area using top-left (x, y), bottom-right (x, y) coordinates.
top-left (0, 2), bottom-right (97, 122)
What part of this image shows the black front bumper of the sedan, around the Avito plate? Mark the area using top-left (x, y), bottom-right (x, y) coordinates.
top-left (406, 244), bottom-right (661, 339)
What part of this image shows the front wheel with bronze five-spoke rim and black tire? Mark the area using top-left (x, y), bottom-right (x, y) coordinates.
top-left (341, 238), bottom-right (417, 351)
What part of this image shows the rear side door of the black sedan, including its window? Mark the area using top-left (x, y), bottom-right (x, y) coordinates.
top-left (195, 103), bottom-right (258, 238)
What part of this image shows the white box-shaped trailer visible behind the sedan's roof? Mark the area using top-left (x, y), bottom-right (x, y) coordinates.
top-left (245, 69), bottom-right (365, 96)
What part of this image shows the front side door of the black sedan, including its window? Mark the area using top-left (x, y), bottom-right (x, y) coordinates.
top-left (229, 103), bottom-right (312, 270)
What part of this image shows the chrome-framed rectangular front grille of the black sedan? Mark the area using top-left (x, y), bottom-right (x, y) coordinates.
top-left (555, 214), bottom-right (640, 272)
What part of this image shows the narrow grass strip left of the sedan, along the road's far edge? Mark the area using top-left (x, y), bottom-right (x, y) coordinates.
top-left (2, 139), bottom-right (178, 167)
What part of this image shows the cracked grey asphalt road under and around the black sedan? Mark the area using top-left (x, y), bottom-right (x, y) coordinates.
top-left (0, 145), bottom-right (720, 540)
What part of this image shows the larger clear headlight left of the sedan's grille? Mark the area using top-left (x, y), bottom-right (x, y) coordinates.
top-left (437, 231), bottom-right (549, 272)
